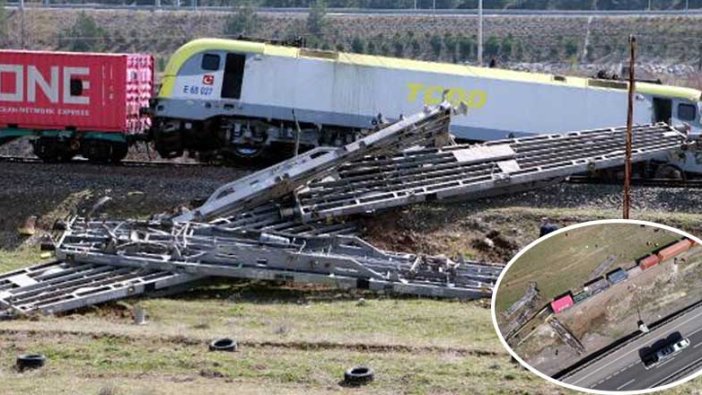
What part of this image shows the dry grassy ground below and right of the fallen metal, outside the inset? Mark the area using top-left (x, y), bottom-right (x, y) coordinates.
top-left (0, 203), bottom-right (702, 395)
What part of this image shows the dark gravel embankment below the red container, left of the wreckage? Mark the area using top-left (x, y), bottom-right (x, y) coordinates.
top-left (0, 163), bottom-right (250, 248)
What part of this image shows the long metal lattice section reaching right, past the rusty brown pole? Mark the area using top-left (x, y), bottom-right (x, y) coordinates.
top-left (295, 124), bottom-right (685, 221)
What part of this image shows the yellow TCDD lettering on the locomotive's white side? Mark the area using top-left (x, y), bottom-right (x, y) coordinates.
top-left (407, 82), bottom-right (487, 109)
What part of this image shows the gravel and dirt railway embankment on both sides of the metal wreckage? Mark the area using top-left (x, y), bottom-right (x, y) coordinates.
top-left (0, 159), bottom-right (702, 261)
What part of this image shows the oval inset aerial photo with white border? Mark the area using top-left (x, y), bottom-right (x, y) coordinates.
top-left (492, 220), bottom-right (702, 394)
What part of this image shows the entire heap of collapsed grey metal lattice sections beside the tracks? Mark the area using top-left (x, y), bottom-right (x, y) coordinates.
top-left (0, 104), bottom-right (684, 316)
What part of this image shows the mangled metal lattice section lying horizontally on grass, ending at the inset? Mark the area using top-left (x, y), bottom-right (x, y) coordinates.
top-left (57, 221), bottom-right (503, 299)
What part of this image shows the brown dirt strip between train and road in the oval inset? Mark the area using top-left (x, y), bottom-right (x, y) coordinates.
top-left (508, 246), bottom-right (702, 375)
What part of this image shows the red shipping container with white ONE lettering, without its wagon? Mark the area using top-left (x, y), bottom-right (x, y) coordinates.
top-left (0, 50), bottom-right (154, 133)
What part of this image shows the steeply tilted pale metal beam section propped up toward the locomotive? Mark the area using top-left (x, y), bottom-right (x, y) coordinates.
top-left (173, 104), bottom-right (453, 222)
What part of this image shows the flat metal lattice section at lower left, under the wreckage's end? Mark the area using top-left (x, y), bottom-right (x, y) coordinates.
top-left (0, 262), bottom-right (201, 318)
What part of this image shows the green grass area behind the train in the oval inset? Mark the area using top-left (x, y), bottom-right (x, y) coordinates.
top-left (496, 224), bottom-right (680, 311)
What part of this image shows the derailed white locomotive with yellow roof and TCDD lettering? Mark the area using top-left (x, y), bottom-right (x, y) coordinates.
top-left (151, 39), bottom-right (702, 176)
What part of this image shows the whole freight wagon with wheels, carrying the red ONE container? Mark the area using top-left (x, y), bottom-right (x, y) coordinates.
top-left (0, 50), bottom-right (154, 162)
